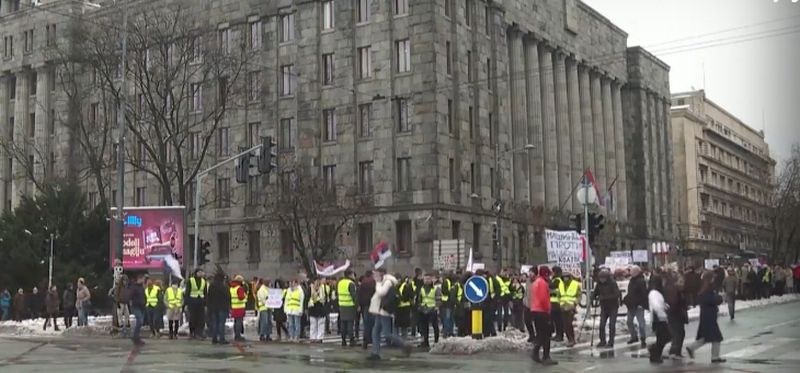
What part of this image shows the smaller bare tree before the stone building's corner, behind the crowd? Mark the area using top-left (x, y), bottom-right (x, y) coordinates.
top-left (264, 168), bottom-right (373, 274)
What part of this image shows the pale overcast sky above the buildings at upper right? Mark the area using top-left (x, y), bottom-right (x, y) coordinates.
top-left (583, 0), bottom-right (800, 162)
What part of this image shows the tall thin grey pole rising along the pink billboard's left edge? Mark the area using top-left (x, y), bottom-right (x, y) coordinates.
top-left (114, 1), bottom-right (128, 274)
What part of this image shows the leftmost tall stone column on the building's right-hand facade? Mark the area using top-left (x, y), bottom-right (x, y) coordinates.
top-left (510, 31), bottom-right (529, 201)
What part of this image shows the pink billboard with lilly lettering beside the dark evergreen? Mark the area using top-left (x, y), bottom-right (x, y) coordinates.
top-left (109, 206), bottom-right (186, 270)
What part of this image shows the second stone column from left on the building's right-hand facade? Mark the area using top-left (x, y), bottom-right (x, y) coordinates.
top-left (525, 39), bottom-right (544, 206)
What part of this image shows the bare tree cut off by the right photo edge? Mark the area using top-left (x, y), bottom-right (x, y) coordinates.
top-left (770, 144), bottom-right (800, 263)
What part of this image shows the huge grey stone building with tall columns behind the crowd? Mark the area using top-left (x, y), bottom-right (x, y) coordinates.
top-left (0, 0), bottom-right (675, 274)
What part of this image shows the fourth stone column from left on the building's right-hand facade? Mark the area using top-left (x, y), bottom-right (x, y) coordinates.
top-left (553, 51), bottom-right (572, 207)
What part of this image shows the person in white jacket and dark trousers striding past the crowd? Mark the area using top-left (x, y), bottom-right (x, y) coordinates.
top-left (367, 268), bottom-right (411, 360)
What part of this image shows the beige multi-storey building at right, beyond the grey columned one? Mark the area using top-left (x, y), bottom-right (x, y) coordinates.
top-left (671, 91), bottom-right (775, 258)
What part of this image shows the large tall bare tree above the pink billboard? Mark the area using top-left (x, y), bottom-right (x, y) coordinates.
top-left (72, 2), bottom-right (247, 205)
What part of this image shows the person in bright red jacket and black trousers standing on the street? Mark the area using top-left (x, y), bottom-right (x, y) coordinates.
top-left (528, 266), bottom-right (558, 365)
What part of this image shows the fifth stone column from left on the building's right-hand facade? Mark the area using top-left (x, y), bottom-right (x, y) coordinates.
top-left (567, 59), bottom-right (583, 211)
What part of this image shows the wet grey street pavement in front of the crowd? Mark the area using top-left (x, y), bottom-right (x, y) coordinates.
top-left (0, 302), bottom-right (800, 373)
